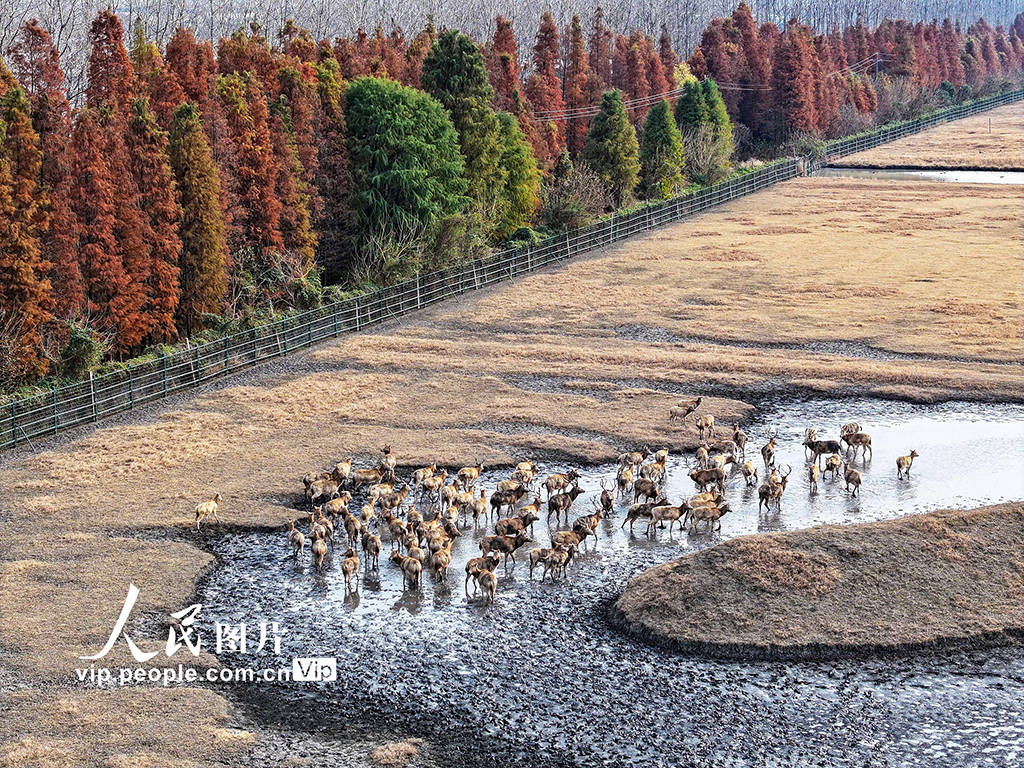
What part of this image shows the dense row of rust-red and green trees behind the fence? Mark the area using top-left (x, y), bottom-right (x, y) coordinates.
top-left (0, 3), bottom-right (1024, 387)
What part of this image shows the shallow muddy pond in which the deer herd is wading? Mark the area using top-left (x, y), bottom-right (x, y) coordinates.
top-left (200, 400), bottom-right (1024, 768)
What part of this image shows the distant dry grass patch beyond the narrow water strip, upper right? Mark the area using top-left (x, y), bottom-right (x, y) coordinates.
top-left (834, 101), bottom-right (1024, 171)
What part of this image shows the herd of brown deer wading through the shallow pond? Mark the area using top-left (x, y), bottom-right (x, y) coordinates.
top-left (196, 397), bottom-right (918, 603)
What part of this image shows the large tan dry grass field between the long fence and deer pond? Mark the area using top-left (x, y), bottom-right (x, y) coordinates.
top-left (0, 171), bottom-right (1024, 768)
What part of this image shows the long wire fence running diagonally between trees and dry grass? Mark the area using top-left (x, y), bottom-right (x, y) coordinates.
top-left (0, 85), bottom-right (1024, 450)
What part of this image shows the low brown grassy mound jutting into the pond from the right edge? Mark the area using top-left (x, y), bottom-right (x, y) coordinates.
top-left (610, 502), bottom-right (1024, 658)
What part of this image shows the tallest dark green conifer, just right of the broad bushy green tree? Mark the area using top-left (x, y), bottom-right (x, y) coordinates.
top-left (420, 30), bottom-right (505, 228)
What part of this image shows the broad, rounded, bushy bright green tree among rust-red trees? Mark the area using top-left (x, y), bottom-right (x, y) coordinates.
top-left (345, 77), bottom-right (469, 276)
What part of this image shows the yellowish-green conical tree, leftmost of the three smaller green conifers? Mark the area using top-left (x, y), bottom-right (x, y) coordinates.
top-left (583, 90), bottom-right (640, 208)
